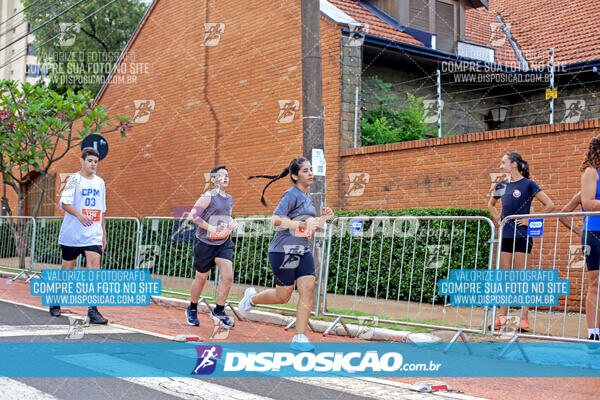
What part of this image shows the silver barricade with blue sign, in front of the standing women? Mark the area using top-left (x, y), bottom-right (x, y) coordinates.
top-left (490, 212), bottom-right (600, 341)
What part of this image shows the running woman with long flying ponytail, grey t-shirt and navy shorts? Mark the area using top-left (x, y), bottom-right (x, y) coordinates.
top-left (238, 158), bottom-right (333, 351)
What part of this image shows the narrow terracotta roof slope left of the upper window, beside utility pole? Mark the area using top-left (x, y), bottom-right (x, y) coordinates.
top-left (327, 0), bottom-right (423, 46)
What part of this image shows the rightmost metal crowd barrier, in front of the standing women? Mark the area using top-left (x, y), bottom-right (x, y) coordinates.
top-left (491, 212), bottom-right (600, 341)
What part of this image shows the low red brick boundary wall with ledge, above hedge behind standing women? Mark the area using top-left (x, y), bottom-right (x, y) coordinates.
top-left (340, 119), bottom-right (600, 209)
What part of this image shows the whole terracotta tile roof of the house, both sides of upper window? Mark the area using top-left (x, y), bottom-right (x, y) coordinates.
top-left (328, 0), bottom-right (600, 68)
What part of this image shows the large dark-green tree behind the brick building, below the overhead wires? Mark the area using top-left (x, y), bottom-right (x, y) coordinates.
top-left (23, 0), bottom-right (148, 94)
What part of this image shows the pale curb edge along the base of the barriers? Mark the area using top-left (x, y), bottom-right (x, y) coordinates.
top-left (152, 296), bottom-right (442, 343)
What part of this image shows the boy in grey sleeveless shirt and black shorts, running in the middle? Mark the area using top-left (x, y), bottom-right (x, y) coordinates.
top-left (185, 165), bottom-right (237, 328)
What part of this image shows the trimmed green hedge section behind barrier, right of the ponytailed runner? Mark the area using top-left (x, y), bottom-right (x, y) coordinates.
top-left (327, 208), bottom-right (490, 303)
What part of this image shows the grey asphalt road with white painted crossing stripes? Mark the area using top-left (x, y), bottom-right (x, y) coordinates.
top-left (0, 300), bottom-right (452, 400)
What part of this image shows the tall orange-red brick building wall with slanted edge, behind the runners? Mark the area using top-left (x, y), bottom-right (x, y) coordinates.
top-left (48, 0), bottom-right (340, 216)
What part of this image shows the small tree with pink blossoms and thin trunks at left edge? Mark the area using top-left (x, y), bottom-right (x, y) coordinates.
top-left (0, 80), bottom-right (131, 267)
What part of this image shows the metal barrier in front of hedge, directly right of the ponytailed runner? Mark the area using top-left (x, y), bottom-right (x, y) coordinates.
top-left (319, 216), bottom-right (495, 342)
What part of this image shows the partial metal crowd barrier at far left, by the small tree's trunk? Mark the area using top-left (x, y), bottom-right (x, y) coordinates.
top-left (0, 216), bottom-right (36, 280)
